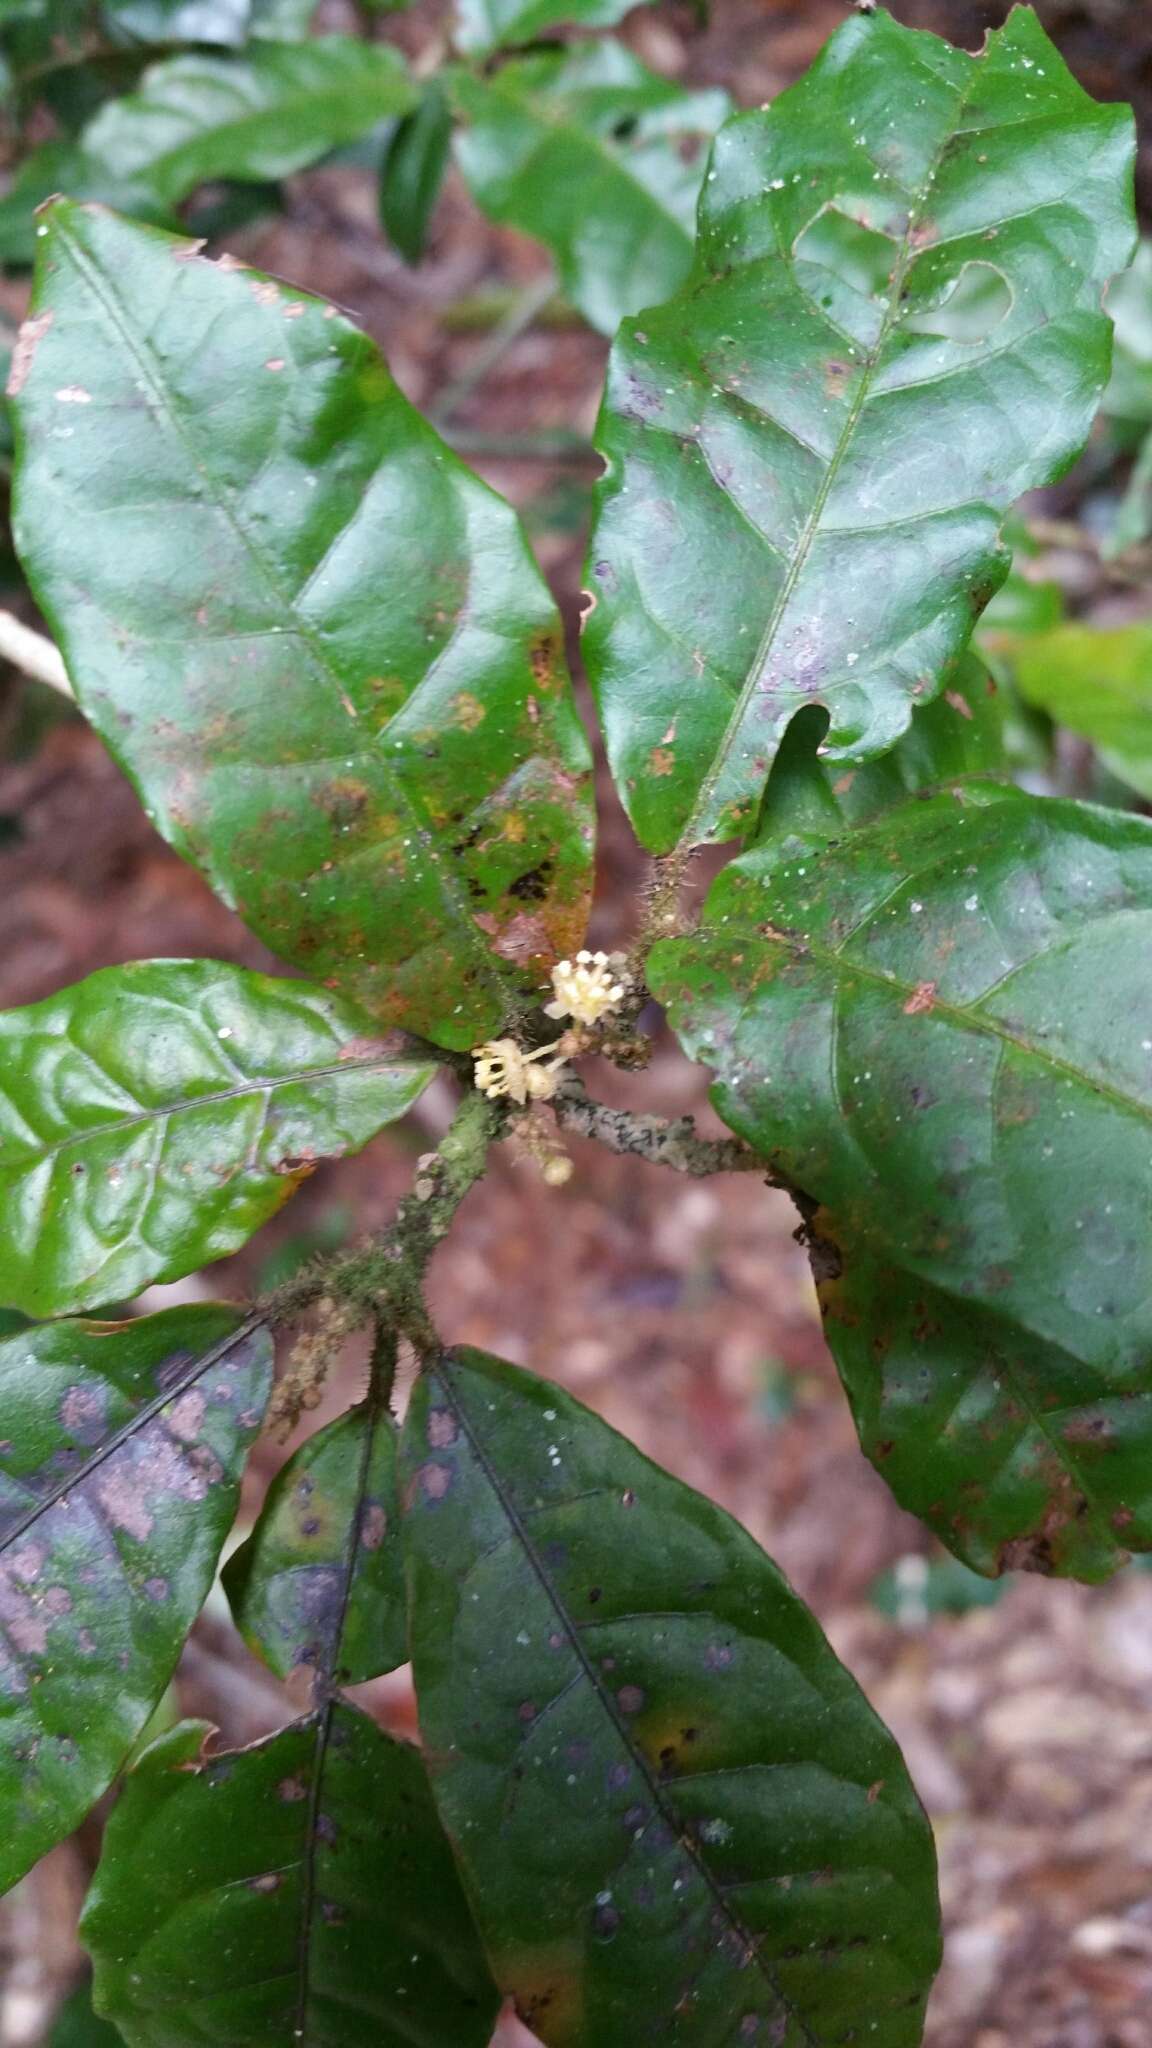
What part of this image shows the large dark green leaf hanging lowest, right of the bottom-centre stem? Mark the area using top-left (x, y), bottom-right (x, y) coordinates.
top-left (402, 1352), bottom-right (939, 2048)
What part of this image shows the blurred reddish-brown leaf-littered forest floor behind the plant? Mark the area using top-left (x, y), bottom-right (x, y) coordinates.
top-left (0, 0), bottom-right (1152, 2048)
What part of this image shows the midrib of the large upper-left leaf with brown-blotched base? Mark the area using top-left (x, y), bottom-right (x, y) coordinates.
top-left (53, 211), bottom-right (510, 1018)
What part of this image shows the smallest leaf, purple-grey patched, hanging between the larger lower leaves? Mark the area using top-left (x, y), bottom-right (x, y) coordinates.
top-left (223, 1401), bottom-right (408, 1686)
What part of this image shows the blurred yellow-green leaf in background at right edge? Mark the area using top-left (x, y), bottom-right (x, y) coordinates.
top-left (1004, 623), bottom-right (1152, 799)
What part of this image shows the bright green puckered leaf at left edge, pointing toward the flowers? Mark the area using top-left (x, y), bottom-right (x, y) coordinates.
top-left (0, 961), bottom-right (435, 1315)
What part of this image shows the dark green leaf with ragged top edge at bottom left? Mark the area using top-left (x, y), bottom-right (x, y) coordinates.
top-left (82, 1702), bottom-right (496, 2048)
